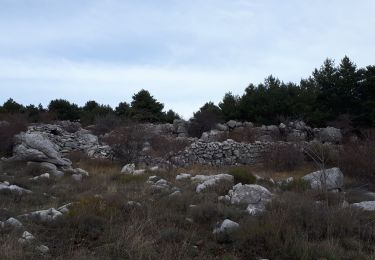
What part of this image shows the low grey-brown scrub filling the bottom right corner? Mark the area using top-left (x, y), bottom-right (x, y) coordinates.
top-left (235, 192), bottom-right (375, 259)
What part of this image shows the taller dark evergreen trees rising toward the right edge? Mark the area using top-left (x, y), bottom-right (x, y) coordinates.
top-left (194, 56), bottom-right (375, 127)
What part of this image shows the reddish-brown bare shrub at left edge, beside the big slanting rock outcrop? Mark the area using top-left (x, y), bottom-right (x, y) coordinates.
top-left (0, 114), bottom-right (27, 157)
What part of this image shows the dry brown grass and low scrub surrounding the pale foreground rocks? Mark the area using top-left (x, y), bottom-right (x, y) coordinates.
top-left (0, 158), bottom-right (375, 260)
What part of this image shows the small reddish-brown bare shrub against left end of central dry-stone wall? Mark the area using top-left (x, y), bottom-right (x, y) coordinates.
top-left (150, 135), bottom-right (191, 158)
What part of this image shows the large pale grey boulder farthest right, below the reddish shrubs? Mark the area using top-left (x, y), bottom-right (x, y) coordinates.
top-left (302, 168), bottom-right (344, 190)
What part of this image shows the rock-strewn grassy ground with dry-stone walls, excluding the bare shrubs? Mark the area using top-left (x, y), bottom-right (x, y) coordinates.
top-left (0, 122), bottom-right (375, 259)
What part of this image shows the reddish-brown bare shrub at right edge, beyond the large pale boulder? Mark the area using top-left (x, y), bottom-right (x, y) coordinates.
top-left (340, 129), bottom-right (375, 185)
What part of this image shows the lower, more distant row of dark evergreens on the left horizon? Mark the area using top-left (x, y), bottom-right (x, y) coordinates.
top-left (0, 89), bottom-right (180, 125)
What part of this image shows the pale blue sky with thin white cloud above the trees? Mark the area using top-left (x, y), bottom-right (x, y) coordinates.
top-left (0, 0), bottom-right (375, 118)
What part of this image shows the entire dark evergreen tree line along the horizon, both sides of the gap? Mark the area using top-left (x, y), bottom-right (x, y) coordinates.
top-left (0, 56), bottom-right (375, 128)
